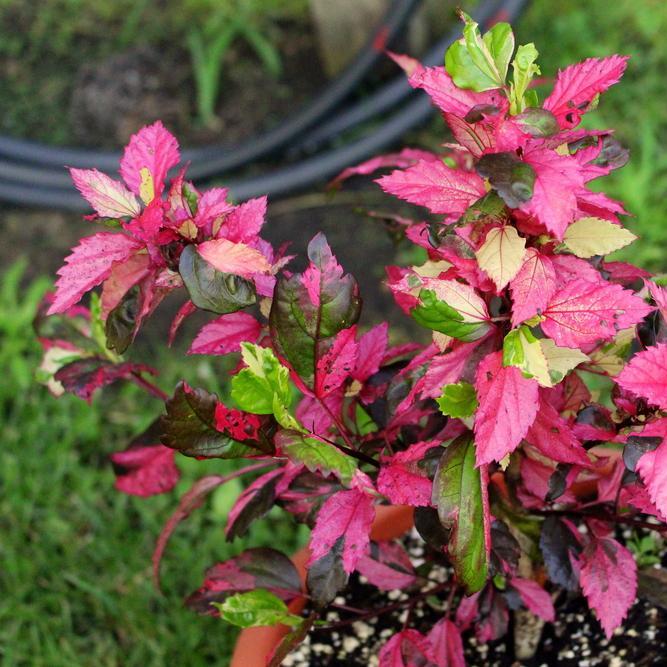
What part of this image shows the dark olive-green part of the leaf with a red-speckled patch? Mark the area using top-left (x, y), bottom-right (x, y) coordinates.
top-left (161, 382), bottom-right (270, 459)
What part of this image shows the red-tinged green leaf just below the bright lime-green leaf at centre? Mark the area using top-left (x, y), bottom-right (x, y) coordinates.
top-left (275, 430), bottom-right (357, 484)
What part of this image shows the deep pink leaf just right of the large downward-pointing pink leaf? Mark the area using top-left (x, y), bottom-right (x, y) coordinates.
top-left (526, 392), bottom-right (590, 466)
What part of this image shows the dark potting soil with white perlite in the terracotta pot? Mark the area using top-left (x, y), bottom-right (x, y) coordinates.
top-left (283, 533), bottom-right (667, 667)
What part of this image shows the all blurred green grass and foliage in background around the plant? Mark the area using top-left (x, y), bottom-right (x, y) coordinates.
top-left (0, 0), bottom-right (667, 667)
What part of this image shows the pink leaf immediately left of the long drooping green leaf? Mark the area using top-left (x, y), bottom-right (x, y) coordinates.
top-left (377, 441), bottom-right (440, 507)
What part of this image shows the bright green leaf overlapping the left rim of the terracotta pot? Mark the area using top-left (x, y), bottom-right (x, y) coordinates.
top-left (213, 588), bottom-right (303, 628)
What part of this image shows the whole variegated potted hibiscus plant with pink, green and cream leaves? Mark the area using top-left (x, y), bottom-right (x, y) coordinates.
top-left (36, 15), bottom-right (667, 667)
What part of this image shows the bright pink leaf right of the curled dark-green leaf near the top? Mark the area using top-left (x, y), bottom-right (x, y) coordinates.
top-left (520, 141), bottom-right (584, 240)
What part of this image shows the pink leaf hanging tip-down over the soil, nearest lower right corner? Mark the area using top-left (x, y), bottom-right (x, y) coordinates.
top-left (580, 537), bottom-right (637, 639)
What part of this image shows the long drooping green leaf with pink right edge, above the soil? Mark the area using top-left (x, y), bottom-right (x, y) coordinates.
top-left (433, 434), bottom-right (489, 595)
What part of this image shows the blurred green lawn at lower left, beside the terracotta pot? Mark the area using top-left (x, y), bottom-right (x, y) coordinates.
top-left (0, 266), bottom-right (303, 667)
